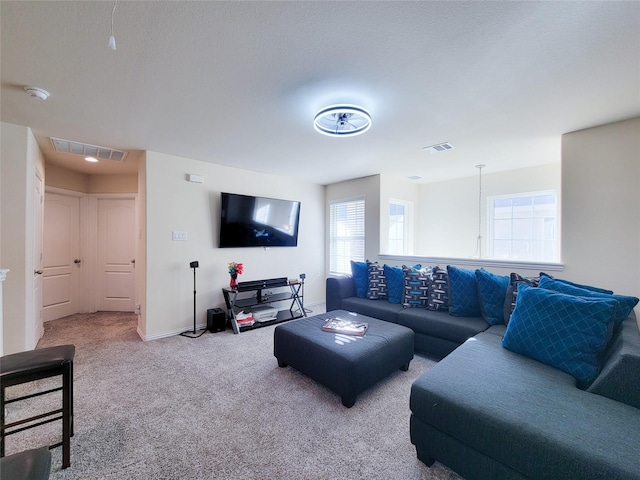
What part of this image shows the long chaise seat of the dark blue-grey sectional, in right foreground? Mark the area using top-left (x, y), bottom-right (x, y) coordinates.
top-left (410, 327), bottom-right (640, 479)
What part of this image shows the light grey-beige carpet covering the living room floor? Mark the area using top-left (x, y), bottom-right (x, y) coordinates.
top-left (7, 313), bottom-right (460, 480)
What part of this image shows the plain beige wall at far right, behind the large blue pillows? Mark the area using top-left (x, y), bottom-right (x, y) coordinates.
top-left (562, 118), bottom-right (640, 298)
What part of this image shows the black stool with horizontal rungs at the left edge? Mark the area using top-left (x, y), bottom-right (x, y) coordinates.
top-left (0, 345), bottom-right (76, 468)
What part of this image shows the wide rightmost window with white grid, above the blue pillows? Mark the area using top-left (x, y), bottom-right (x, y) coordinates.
top-left (488, 191), bottom-right (559, 262)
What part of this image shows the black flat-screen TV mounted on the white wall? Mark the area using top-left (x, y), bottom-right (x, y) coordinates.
top-left (219, 192), bottom-right (300, 248)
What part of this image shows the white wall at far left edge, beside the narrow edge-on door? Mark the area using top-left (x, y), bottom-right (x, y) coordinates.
top-left (0, 123), bottom-right (44, 354)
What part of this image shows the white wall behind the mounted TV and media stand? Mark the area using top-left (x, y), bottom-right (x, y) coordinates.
top-left (140, 152), bottom-right (325, 339)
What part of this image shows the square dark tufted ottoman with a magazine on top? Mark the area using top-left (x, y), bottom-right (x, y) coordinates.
top-left (273, 310), bottom-right (413, 408)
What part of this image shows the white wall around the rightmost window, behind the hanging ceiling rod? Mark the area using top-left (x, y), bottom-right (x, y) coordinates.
top-left (415, 163), bottom-right (562, 258)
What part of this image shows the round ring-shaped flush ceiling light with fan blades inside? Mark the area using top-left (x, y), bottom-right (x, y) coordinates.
top-left (313, 105), bottom-right (371, 137)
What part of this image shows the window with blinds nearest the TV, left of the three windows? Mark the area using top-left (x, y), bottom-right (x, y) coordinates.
top-left (329, 197), bottom-right (365, 273)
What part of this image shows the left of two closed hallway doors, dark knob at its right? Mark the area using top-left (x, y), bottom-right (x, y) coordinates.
top-left (42, 192), bottom-right (83, 322)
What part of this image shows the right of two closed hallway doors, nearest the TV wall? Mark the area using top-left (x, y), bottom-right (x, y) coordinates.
top-left (97, 198), bottom-right (136, 312)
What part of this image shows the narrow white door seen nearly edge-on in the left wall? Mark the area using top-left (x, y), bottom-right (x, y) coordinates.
top-left (32, 173), bottom-right (44, 348)
